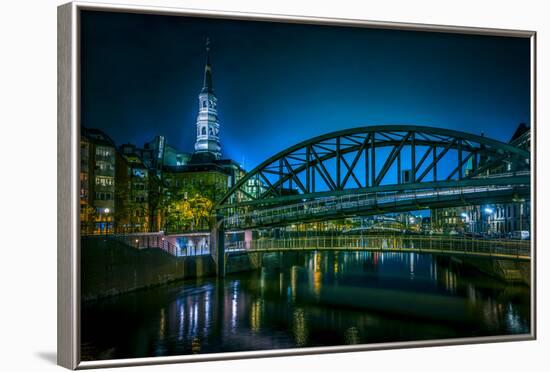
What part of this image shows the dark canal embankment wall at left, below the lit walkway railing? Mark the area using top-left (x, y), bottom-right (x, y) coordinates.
top-left (80, 238), bottom-right (216, 301)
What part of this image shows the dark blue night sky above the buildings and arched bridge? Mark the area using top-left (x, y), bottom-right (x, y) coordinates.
top-left (81, 11), bottom-right (530, 169)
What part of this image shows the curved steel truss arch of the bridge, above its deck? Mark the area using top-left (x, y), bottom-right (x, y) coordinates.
top-left (216, 125), bottom-right (530, 211)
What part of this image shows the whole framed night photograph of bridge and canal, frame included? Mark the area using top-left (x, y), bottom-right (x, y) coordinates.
top-left (58, 2), bottom-right (536, 369)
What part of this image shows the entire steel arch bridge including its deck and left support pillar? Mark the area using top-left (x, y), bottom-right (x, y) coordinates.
top-left (212, 125), bottom-right (530, 272)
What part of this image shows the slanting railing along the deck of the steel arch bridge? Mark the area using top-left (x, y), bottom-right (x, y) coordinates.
top-left (225, 185), bottom-right (528, 227)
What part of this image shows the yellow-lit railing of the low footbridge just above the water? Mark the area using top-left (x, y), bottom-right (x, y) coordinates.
top-left (225, 235), bottom-right (531, 259)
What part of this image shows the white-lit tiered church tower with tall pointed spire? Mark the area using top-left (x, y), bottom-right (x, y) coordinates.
top-left (195, 39), bottom-right (221, 159)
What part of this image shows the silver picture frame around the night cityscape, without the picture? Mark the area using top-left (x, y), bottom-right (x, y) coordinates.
top-left (57, 1), bottom-right (537, 369)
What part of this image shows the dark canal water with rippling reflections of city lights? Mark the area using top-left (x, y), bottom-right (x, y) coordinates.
top-left (81, 252), bottom-right (530, 360)
